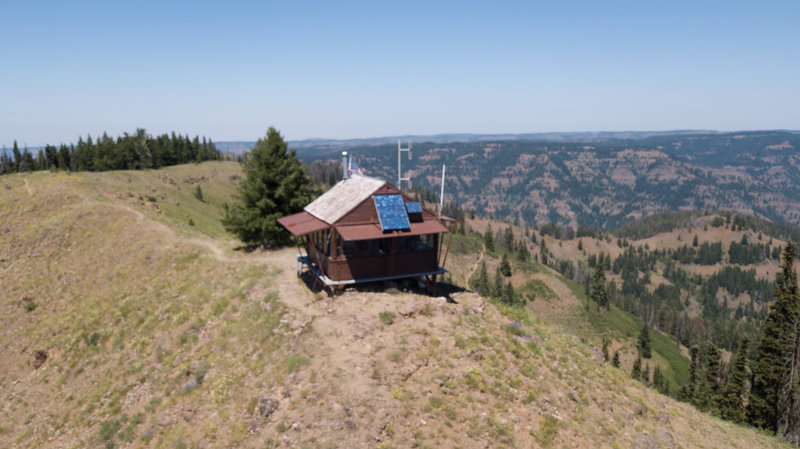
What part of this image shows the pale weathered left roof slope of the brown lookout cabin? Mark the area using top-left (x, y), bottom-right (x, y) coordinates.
top-left (305, 175), bottom-right (386, 224)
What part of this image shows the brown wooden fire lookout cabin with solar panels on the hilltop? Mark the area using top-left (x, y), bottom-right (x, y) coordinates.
top-left (278, 155), bottom-right (454, 294)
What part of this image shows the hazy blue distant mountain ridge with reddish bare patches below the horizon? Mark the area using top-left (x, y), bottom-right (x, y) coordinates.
top-left (293, 131), bottom-right (800, 229)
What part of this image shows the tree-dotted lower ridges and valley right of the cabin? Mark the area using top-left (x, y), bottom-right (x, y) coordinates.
top-left (446, 206), bottom-right (800, 443)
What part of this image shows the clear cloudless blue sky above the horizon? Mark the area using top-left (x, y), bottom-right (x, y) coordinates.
top-left (0, 0), bottom-right (800, 146)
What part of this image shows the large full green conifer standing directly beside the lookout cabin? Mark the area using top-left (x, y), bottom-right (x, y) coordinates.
top-left (223, 128), bottom-right (314, 247)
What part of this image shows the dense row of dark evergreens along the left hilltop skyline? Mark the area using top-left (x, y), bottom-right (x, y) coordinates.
top-left (0, 128), bottom-right (222, 174)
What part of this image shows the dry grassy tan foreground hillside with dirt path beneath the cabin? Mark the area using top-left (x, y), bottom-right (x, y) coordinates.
top-left (0, 163), bottom-right (781, 448)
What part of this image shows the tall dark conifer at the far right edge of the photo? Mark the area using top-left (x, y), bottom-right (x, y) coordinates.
top-left (747, 241), bottom-right (798, 431)
